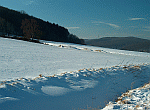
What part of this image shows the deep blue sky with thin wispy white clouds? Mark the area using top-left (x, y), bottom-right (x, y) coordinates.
top-left (0, 0), bottom-right (150, 39)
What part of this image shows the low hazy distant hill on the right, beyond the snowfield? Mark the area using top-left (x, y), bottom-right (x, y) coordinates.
top-left (85, 37), bottom-right (150, 53)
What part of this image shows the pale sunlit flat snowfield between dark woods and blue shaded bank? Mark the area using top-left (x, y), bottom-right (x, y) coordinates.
top-left (0, 38), bottom-right (150, 81)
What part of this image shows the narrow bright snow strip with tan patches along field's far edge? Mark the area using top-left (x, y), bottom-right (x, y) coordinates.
top-left (40, 40), bottom-right (150, 57)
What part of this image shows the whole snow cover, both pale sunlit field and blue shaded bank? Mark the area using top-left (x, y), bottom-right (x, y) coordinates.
top-left (0, 38), bottom-right (150, 110)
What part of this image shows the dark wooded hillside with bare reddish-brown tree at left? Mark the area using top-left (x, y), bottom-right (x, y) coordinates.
top-left (0, 6), bottom-right (84, 44)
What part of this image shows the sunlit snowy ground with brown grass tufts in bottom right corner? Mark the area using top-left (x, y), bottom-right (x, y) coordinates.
top-left (103, 83), bottom-right (150, 110)
